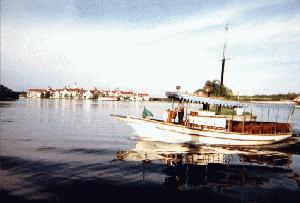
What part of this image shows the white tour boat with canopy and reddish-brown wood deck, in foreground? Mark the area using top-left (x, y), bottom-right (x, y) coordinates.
top-left (113, 92), bottom-right (295, 145)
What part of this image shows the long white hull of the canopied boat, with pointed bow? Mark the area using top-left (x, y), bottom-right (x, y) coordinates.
top-left (122, 117), bottom-right (292, 145)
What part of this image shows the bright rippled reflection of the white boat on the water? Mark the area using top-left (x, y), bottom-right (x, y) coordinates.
top-left (117, 140), bottom-right (291, 167)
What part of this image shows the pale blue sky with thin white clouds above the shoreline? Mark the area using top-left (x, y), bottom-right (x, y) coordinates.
top-left (1, 0), bottom-right (300, 95)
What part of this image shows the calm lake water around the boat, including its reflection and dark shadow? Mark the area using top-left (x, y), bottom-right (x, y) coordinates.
top-left (0, 99), bottom-right (300, 202)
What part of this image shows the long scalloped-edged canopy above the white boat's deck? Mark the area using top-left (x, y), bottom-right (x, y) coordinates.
top-left (166, 92), bottom-right (295, 110)
